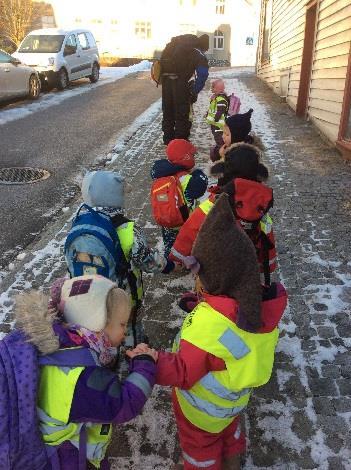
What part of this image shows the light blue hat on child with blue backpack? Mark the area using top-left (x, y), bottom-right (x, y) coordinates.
top-left (82, 171), bottom-right (124, 208)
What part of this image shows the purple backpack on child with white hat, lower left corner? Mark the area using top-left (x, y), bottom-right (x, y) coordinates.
top-left (0, 330), bottom-right (96, 470)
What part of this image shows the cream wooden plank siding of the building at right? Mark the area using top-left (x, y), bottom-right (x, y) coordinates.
top-left (257, 0), bottom-right (351, 142)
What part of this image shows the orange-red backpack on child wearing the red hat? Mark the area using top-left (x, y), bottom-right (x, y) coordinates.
top-left (151, 175), bottom-right (189, 228)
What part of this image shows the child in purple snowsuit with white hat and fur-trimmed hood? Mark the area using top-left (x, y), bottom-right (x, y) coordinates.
top-left (15, 275), bottom-right (157, 470)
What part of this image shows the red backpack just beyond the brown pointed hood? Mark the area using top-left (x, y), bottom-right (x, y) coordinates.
top-left (225, 178), bottom-right (275, 286)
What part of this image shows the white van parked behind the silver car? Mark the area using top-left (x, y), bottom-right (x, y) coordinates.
top-left (13, 28), bottom-right (100, 90)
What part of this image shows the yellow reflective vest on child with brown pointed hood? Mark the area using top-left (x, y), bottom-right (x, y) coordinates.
top-left (173, 302), bottom-right (279, 433)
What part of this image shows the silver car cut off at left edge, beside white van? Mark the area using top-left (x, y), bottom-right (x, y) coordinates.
top-left (0, 50), bottom-right (40, 101)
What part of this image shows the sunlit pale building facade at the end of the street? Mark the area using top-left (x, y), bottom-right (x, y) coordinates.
top-left (46, 0), bottom-right (259, 66)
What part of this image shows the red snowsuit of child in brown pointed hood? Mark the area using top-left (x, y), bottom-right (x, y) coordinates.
top-left (156, 285), bottom-right (287, 470)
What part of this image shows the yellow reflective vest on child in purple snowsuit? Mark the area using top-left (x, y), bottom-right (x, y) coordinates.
top-left (38, 360), bottom-right (112, 468)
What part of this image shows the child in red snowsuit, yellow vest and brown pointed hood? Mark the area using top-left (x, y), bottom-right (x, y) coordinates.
top-left (140, 194), bottom-right (287, 470)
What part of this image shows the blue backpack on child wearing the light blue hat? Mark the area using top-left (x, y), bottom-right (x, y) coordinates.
top-left (64, 204), bottom-right (128, 281)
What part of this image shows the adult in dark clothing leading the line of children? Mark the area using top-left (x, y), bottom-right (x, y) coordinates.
top-left (161, 34), bottom-right (209, 145)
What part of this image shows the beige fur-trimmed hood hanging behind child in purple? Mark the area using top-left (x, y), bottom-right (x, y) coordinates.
top-left (15, 291), bottom-right (60, 354)
